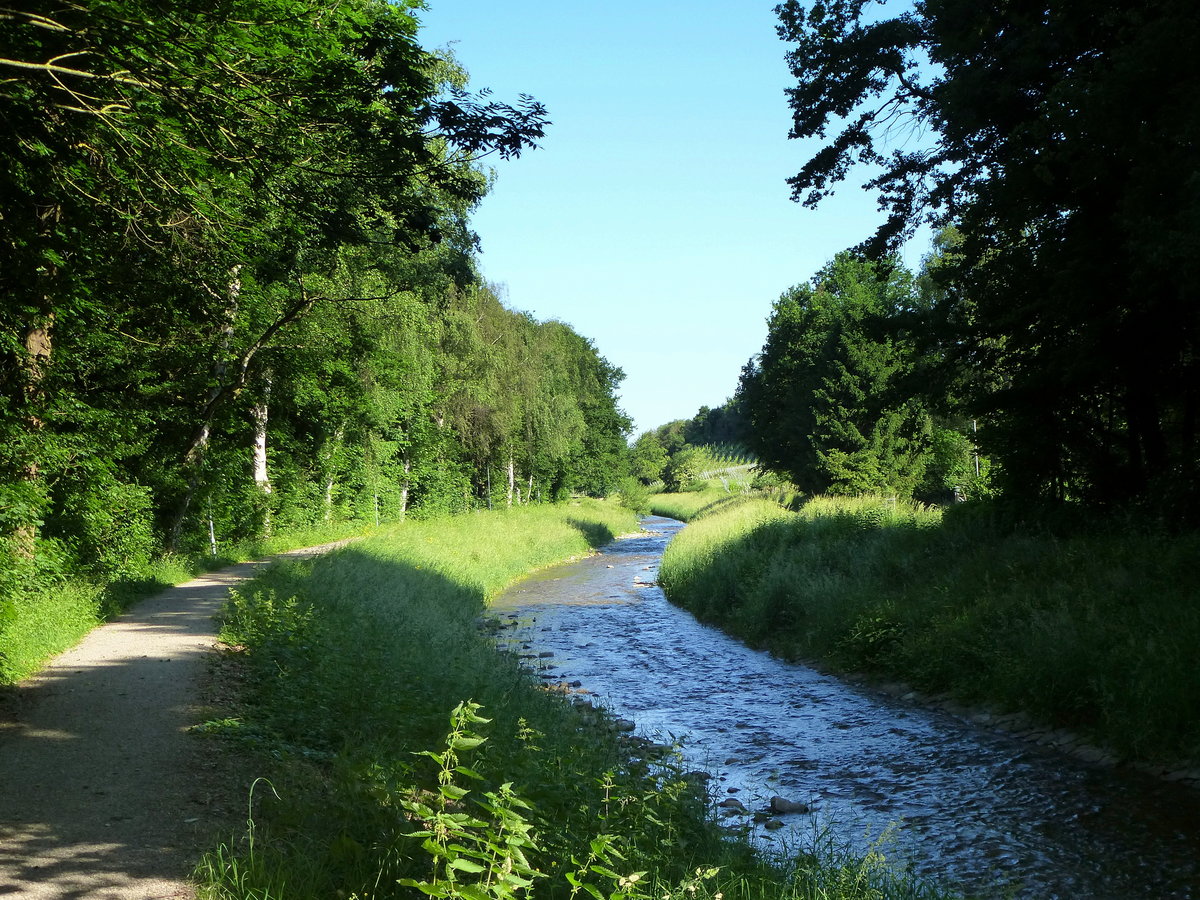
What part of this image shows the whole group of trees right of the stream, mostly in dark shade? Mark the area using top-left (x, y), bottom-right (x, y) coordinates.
top-left (633, 0), bottom-right (1200, 524)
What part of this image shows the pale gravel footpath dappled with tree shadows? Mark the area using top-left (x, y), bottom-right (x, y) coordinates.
top-left (0, 541), bottom-right (346, 900)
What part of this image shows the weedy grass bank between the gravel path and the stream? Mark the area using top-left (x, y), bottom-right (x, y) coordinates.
top-left (199, 502), bottom-right (932, 900)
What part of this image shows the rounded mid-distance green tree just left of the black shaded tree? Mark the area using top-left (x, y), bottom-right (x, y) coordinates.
top-left (738, 253), bottom-right (929, 496)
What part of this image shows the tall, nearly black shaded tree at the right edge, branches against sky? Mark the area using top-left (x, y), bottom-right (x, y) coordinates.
top-left (776, 0), bottom-right (1200, 502)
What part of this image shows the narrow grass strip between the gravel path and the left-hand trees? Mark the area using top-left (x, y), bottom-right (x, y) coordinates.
top-left (0, 523), bottom-right (365, 685)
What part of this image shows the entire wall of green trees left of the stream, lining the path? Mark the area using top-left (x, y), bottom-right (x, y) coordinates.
top-left (0, 0), bottom-right (629, 585)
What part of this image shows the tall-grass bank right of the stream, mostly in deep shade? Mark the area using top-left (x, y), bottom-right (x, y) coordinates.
top-left (660, 498), bottom-right (1200, 764)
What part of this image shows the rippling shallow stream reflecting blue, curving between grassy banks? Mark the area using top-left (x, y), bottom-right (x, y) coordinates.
top-left (492, 517), bottom-right (1200, 900)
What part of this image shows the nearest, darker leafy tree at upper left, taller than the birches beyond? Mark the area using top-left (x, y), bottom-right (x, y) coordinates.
top-left (0, 0), bottom-right (545, 553)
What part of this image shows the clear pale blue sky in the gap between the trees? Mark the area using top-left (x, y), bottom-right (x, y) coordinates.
top-left (419, 0), bottom-right (928, 434)
